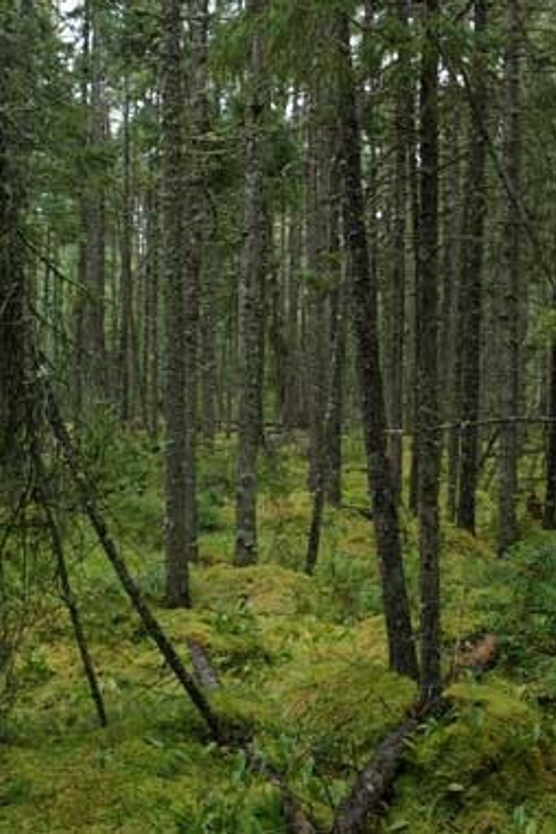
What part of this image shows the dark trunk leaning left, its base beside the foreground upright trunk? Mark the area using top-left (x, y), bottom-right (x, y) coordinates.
top-left (336, 13), bottom-right (418, 678)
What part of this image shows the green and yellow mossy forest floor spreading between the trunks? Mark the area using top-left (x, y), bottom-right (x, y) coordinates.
top-left (0, 431), bottom-right (556, 834)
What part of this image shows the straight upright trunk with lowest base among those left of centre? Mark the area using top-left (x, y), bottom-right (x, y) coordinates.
top-left (162, 0), bottom-right (190, 607)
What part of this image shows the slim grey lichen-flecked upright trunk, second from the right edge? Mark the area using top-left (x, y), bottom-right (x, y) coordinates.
top-left (498, 0), bottom-right (521, 555)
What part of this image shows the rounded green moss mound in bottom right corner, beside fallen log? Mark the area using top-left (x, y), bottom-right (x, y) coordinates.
top-left (384, 679), bottom-right (556, 834)
